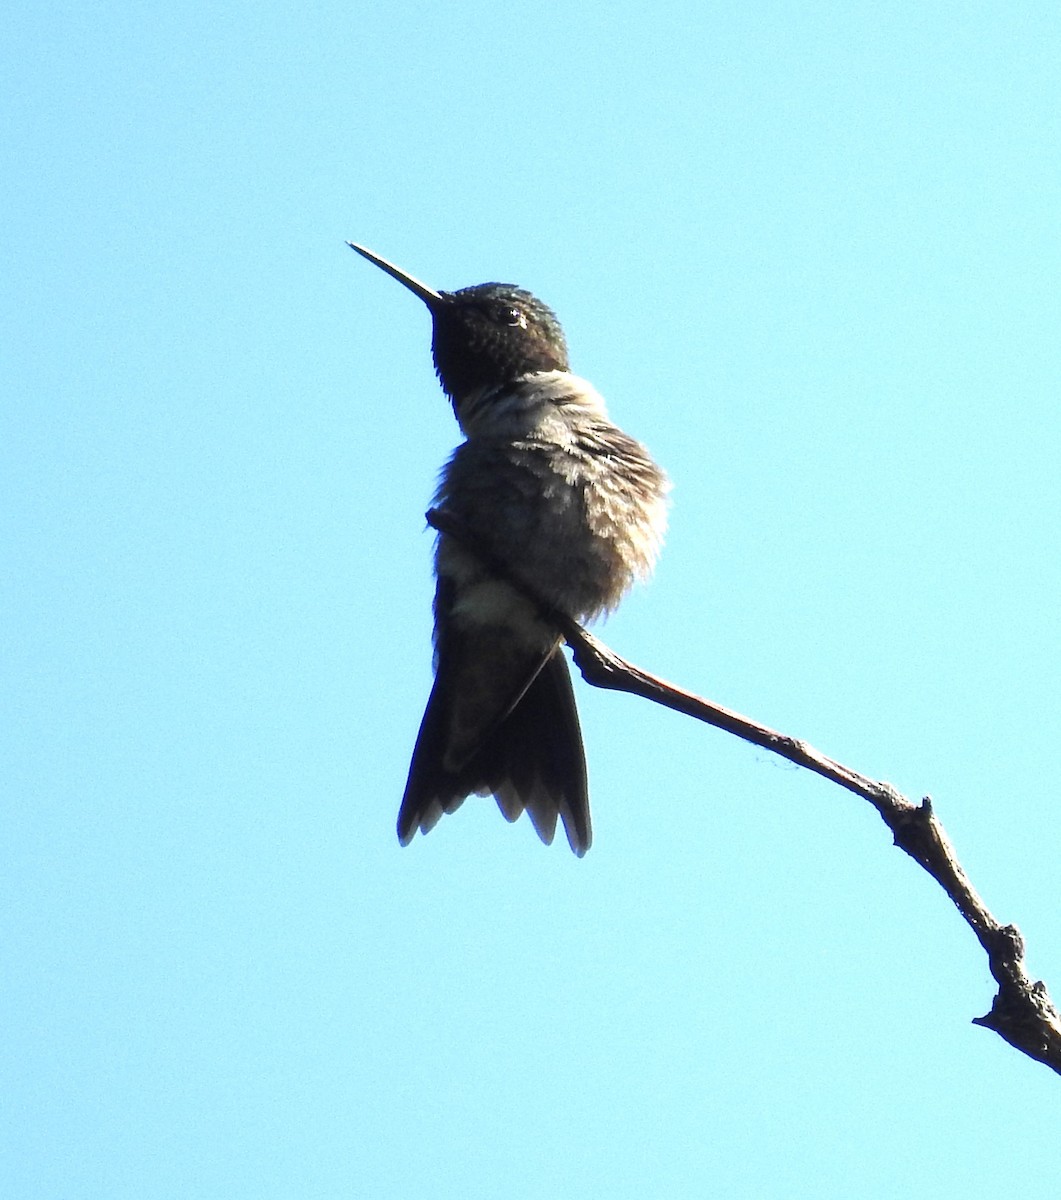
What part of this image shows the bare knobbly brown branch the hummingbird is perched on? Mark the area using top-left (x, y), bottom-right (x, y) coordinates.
top-left (427, 509), bottom-right (1061, 1074)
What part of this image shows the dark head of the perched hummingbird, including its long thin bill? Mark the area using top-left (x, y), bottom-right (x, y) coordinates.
top-left (347, 242), bottom-right (569, 406)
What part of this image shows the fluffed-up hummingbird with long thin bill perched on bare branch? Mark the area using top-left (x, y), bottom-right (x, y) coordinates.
top-left (347, 242), bottom-right (670, 858)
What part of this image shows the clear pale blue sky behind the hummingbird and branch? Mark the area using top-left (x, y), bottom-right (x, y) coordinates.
top-left (0, 0), bottom-right (1061, 1200)
